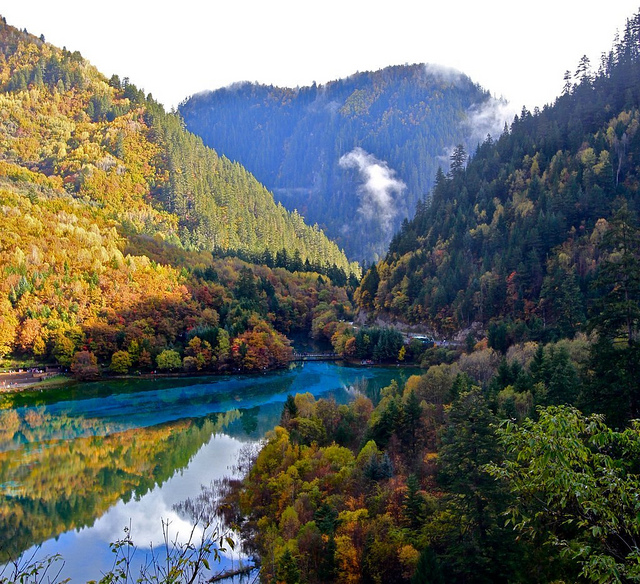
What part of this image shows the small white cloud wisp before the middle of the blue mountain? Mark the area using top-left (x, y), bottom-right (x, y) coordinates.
top-left (339, 147), bottom-right (407, 229)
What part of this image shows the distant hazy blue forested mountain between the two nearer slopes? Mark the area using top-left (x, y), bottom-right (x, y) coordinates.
top-left (179, 65), bottom-right (504, 261)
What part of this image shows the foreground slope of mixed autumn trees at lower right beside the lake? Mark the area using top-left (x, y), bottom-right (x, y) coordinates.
top-left (230, 338), bottom-right (640, 584)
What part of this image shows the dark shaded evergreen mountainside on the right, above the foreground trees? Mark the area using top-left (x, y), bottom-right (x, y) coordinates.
top-left (357, 11), bottom-right (640, 341)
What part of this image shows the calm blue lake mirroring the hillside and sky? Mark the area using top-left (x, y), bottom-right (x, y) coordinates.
top-left (0, 362), bottom-right (417, 582)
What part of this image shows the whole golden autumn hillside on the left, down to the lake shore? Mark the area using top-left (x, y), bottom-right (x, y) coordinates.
top-left (0, 20), bottom-right (359, 373)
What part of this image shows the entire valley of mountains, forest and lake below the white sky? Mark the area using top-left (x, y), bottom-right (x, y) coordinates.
top-left (0, 8), bottom-right (640, 584)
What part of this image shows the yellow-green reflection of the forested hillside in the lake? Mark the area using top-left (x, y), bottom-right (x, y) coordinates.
top-left (0, 409), bottom-right (241, 561)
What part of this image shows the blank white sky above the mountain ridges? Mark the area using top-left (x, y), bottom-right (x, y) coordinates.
top-left (0, 0), bottom-right (640, 110)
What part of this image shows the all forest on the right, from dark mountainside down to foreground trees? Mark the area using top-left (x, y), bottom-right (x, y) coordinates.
top-left (225, 13), bottom-right (640, 584)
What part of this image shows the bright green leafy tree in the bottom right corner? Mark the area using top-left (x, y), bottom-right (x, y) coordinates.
top-left (487, 406), bottom-right (640, 583)
